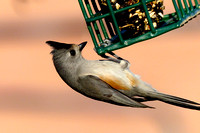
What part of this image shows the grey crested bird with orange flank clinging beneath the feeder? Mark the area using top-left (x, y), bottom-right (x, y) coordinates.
top-left (46, 41), bottom-right (200, 110)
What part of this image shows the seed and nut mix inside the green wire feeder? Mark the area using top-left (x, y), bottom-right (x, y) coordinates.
top-left (99, 0), bottom-right (165, 38)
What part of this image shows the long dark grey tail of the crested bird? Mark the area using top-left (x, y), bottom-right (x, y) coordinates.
top-left (148, 91), bottom-right (200, 110)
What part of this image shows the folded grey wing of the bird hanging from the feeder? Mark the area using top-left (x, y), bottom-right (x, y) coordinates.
top-left (78, 75), bottom-right (152, 108)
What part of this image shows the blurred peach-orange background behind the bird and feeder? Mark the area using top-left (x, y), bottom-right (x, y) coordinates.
top-left (0, 0), bottom-right (200, 133)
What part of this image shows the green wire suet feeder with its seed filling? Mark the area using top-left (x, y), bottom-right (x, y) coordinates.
top-left (78, 0), bottom-right (200, 55)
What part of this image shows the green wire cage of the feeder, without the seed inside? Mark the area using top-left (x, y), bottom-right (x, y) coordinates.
top-left (78, 0), bottom-right (200, 55)
